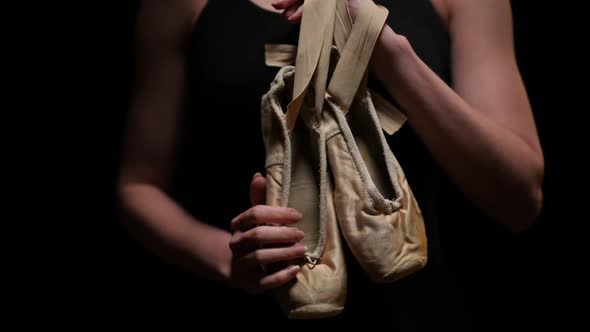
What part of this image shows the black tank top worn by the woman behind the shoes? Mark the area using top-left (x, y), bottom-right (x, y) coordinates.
top-left (173, 0), bottom-right (503, 331)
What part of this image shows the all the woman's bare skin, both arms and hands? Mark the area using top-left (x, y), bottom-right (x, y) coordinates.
top-left (119, 0), bottom-right (544, 292)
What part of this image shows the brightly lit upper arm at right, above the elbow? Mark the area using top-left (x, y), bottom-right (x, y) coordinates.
top-left (445, 0), bottom-right (540, 151)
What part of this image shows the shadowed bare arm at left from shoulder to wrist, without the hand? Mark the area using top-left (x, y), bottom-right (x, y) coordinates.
top-left (119, 0), bottom-right (231, 280)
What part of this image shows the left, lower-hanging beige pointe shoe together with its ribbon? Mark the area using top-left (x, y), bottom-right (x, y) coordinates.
top-left (262, 0), bottom-right (347, 319)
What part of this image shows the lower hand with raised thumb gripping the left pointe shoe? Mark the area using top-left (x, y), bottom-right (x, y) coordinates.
top-left (229, 174), bottom-right (305, 293)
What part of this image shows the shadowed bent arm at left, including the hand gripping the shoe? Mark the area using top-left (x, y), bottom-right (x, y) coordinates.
top-left (119, 0), bottom-right (305, 291)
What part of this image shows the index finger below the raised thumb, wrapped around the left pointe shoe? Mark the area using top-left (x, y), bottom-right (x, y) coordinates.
top-left (230, 205), bottom-right (302, 231)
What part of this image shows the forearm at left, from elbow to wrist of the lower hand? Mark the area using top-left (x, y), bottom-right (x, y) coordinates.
top-left (120, 183), bottom-right (231, 282)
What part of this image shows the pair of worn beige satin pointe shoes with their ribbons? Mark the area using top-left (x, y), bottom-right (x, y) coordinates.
top-left (261, 0), bottom-right (426, 319)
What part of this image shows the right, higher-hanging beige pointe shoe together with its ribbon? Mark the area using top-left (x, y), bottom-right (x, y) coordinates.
top-left (323, 1), bottom-right (427, 282)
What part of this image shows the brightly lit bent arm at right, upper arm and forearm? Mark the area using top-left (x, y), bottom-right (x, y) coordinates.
top-left (372, 0), bottom-right (544, 231)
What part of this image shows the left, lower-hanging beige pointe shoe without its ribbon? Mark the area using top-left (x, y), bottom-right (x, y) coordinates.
top-left (262, 67), bottom-right (347, 319)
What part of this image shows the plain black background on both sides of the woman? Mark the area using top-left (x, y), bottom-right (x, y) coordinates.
top-left (11, 1), bottom-right (590, 331)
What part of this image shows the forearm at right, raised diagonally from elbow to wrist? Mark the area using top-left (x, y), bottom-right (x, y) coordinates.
top-left (371, 26), bottom-right (542, 229)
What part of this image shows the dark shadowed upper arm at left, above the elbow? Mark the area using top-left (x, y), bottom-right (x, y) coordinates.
top-left (121, 0), bottom-right (206, 188)
